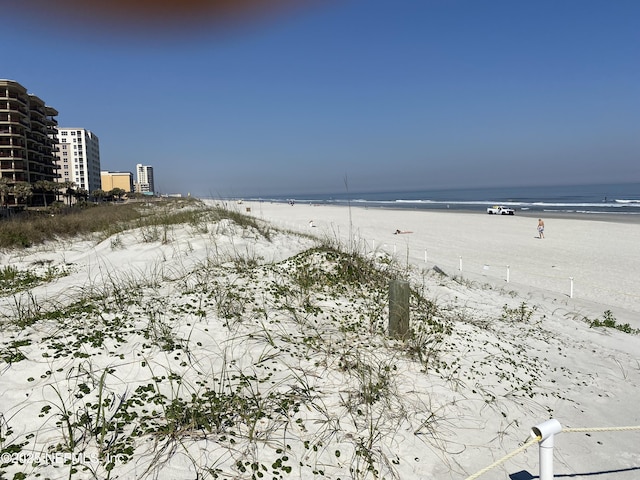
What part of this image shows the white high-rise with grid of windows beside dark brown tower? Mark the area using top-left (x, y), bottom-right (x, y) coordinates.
top-left (57, 128), bottom-right (102, 194)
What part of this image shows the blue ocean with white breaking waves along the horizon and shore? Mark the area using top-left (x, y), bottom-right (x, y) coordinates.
top-left (245, 183), bottom-right (640, 215)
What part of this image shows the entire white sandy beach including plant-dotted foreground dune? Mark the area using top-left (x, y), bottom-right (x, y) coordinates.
top-left (0, 198), bottom-right (640, 480)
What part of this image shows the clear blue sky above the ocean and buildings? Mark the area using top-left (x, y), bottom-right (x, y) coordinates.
top-left (0, 0), bottom-right (640, 197)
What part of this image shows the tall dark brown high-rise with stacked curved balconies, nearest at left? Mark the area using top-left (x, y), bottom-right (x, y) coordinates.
top-left (0, 79), bottom-right (58, 208)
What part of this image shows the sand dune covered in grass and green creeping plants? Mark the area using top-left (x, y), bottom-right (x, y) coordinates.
top-left (0, 200), bottom-right (640, 479)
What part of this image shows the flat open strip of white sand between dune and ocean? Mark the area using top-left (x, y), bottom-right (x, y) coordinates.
top-left (244, 203), bottom-right (640, 328)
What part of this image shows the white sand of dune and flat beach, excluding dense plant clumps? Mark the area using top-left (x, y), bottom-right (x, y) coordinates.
top-left (0, 203), bottom-right (640, 480)
